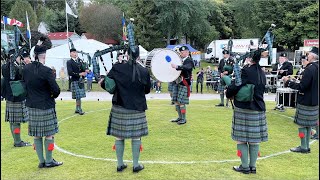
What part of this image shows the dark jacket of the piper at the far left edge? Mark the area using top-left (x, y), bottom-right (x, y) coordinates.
top-left (1, 62), bottom-right (26, 102)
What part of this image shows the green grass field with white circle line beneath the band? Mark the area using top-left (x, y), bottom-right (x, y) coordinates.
top-left (1, 100), bottom-right (319, 180)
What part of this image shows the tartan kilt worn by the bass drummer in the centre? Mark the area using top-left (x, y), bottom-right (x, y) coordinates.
top-left (171, 84), bottom-right (189, 104)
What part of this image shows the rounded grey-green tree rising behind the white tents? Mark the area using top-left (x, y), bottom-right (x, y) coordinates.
top-left (79, 4), bottom-right (122, 41)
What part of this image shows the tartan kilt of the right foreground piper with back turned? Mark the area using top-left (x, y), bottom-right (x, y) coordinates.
top-left (231, 107), bottom-right (268, 143)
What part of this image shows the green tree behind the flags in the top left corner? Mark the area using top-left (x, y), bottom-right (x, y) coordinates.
top-left (10, 0), bottom-right (38, 30)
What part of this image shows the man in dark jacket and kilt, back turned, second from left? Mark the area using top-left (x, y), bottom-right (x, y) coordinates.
top-left (23, 45), bottom-right (63, 168)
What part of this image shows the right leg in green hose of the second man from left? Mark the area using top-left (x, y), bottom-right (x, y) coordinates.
top-left (44, 136), bottom-right (63, 168)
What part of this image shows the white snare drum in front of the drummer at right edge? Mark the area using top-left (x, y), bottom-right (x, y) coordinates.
top-left (276, 88), bottom-right (298, 108)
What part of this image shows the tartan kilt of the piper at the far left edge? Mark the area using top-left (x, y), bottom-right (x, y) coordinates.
top-left (5, 100), bottom-right (29, 123)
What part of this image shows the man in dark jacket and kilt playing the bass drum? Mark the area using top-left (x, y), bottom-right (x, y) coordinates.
top-left (171, 46), bottom-right (194, 125)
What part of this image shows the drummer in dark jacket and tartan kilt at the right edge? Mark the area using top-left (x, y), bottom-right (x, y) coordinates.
top-left (283, 47), bottom-right (319, 153)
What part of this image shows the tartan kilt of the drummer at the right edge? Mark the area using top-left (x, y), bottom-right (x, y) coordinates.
top-left (294, 103), bottom-right (319, 127)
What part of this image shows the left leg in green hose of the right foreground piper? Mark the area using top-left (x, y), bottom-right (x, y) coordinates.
top-left (233, 142), bottom-right (250, 174)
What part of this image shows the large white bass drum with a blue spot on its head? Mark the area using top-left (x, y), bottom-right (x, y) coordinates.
top-left (144, 48), bottom-right (182, 82)
